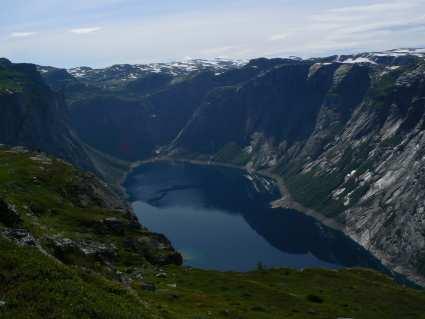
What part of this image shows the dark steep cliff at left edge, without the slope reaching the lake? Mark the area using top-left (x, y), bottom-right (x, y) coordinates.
top-left (0, 60), bottom-right (94, 170)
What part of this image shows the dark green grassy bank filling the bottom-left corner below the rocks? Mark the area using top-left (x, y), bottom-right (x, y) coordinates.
top-left (0, 237), bottom-right (150, 319)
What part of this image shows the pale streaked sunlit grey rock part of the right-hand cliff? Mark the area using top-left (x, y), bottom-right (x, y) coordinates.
top-left (280, 63), bottom-right (425, 284)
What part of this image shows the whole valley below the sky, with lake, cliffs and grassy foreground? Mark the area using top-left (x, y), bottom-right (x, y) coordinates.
top-left (0, 49), bottom-right (425, 319)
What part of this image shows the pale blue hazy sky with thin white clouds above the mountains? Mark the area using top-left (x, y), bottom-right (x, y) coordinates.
top-left (0, 0), bottom-right (425, 67)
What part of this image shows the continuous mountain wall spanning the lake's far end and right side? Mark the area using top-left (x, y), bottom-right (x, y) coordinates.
top-left (39, 49), bottom-right (425, 282)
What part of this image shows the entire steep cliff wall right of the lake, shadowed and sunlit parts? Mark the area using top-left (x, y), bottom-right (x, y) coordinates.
top-left (169, 57), bottom-right (425, 281)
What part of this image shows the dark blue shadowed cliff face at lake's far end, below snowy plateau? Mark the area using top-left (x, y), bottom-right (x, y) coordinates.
top-left (69, 72), bottom-right (220, 160)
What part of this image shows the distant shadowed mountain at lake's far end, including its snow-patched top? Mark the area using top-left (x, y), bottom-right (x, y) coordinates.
top-left (39, 60), bottom-right (284, 160)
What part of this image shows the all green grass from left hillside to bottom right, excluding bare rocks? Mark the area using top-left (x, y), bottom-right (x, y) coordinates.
top-left (0, 150), bottom-right (425, 319)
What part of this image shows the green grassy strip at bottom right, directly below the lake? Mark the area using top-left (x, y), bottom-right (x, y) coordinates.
top-left (134, 267), bottom-right (425, 319)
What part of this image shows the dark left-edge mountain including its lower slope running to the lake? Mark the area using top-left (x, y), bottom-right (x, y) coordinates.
top-left (0, 59), bottom-right (132, 192)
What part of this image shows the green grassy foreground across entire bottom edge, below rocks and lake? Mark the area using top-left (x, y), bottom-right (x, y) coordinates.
top-left (0, 240), bottom-right (425, 319)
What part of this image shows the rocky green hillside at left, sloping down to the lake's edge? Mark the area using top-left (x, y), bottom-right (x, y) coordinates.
top-left (0, 150), bottom-right (179, 273)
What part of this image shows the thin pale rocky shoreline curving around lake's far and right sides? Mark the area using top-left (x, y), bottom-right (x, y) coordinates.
top-left (118, 157), bottom-right (425, 289)
